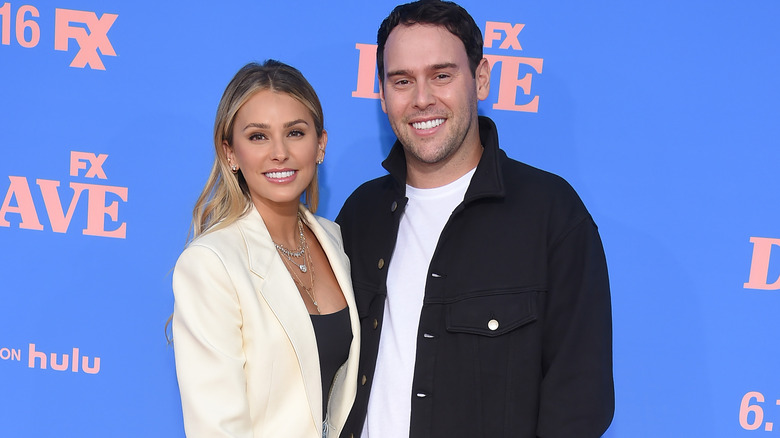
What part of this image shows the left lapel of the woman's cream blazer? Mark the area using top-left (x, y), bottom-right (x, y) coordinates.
top-left (239, 207), bottom-right (322, 434)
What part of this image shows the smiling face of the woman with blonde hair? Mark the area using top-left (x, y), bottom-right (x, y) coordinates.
top-left (222, 90), bottom-right (328, 211)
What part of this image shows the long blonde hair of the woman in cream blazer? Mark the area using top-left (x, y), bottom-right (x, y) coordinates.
top-left (190, 59), bottom-right (324, 239)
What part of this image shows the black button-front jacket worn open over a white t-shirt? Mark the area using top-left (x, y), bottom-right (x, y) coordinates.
top-left (336, 117), bottom-right (614, 438)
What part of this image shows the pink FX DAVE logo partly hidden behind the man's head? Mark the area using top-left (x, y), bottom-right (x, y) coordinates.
top-left (352, 21), bottom-right (544, 113)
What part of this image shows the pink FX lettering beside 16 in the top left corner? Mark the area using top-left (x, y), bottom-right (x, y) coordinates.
top-left (54, 8), bottom-right (119, 70)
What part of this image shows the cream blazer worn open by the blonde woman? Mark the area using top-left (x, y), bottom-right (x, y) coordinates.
top-left (173, 206), bottom-right (360, 438)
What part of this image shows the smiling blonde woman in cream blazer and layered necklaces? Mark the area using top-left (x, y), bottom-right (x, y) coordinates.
top-left (173, 60), bottom-right (360, 438)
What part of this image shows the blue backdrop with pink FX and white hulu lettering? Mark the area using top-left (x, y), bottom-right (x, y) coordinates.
top-left (0, 0), bottom-right (780, 438)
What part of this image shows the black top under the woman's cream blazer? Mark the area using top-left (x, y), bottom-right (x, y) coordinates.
top-left (311, 307), bottom-right (352, 421)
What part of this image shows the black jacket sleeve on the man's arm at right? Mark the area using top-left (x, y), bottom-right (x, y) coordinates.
top-left (537, 216), bottom-right (615, 438)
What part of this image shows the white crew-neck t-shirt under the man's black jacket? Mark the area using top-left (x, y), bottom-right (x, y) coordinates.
top-left (361, 169), bottom-right (474, 438)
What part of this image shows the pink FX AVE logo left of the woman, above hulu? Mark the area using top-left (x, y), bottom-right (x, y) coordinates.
top-left (0, 151), bottom-right (127, 239)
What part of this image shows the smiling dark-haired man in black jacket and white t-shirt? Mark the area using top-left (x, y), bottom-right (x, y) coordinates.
top-left (337, 1), bottom-right (614, 438)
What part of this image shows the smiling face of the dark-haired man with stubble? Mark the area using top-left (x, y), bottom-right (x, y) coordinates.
top-left (379, 24), bottom-right (490, 166)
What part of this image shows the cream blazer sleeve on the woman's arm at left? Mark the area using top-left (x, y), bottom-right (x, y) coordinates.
top-left (173, 244), bottom-right (252, 438)
